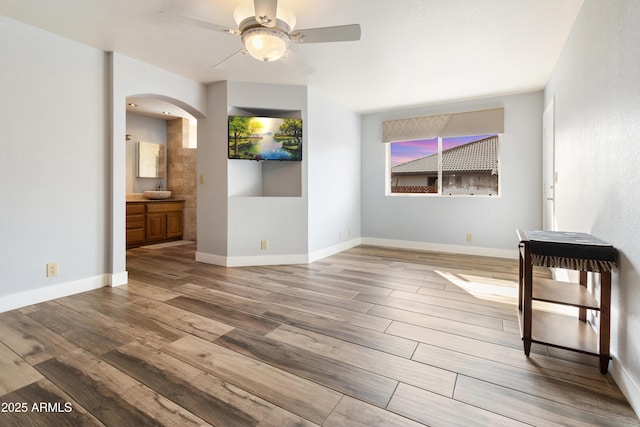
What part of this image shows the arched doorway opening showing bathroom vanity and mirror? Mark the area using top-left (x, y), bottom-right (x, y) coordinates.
top-left (125, 95), bottom-right (197, 249)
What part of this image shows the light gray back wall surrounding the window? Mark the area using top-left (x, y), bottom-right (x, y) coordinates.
top-left (362, 91), bottom-right (543, 257)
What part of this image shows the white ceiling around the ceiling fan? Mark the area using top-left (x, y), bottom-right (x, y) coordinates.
top-left (0, 0), bottom-right (583, 113)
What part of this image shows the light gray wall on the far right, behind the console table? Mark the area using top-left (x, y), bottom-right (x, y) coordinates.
top-left (545, 0), bottom-right (640, 413)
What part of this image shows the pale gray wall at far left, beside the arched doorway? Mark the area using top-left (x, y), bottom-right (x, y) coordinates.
top-left (0, 16), bottom-right (110, 311)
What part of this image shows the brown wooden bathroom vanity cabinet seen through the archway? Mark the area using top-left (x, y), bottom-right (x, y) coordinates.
top-left (127, 200), bottom-right (184, 248)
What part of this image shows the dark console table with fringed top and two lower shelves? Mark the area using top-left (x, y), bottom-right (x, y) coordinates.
top-left (516, 230), bottom-right (617, 374)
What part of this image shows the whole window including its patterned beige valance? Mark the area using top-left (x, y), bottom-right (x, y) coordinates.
top-left (382, 108), bottom-right (504, 196)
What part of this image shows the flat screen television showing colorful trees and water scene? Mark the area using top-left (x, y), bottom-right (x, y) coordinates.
top-left (229, 116), bottom-right (302, 161)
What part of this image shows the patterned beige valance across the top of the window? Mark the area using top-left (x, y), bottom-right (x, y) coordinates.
top-left (382, 108), bottom-right (504, 142)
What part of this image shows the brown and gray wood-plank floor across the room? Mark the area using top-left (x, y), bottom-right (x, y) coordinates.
top-left (0, 244), bottom-right (640, 427)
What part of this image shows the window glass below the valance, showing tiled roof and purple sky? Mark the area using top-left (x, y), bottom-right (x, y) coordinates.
top-left (388, 134), bottom-right (500, 196)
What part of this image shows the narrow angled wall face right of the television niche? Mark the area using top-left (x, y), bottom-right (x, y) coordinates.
top-left (306, 88), bottom-right (361, 254)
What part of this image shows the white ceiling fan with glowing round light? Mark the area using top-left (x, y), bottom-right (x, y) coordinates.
top-left (162, 0), bottom-right (361, 62)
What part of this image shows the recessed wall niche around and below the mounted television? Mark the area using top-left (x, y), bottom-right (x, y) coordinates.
top-left (228, 107), bottom-right (306, 197)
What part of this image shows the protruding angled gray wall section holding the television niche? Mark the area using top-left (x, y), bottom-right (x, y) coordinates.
top-left (196, 82), bottom-right (360, 266)
